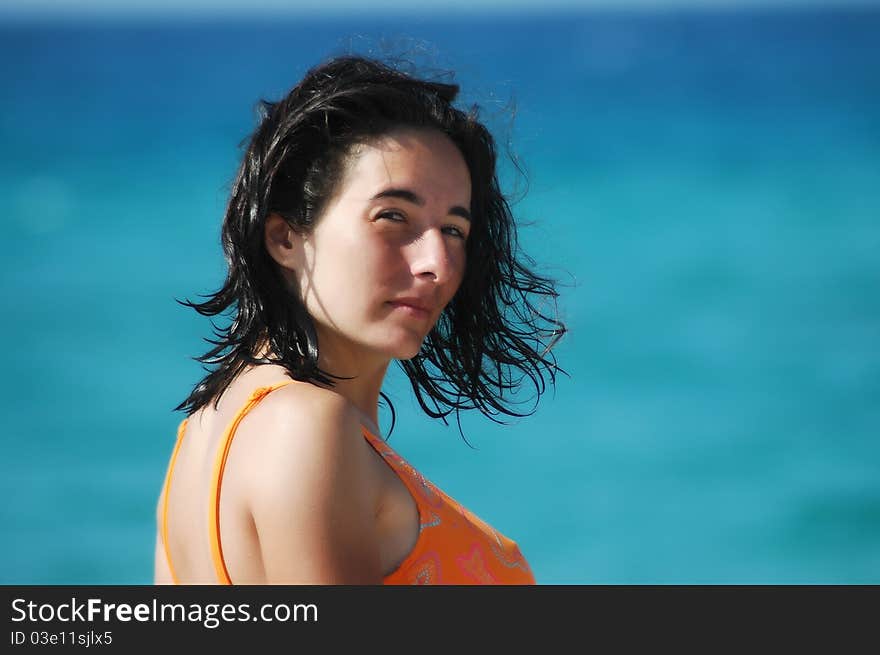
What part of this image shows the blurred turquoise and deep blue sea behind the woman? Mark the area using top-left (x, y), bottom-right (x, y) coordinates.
top-left (0, 9), bottom-right (880, 584)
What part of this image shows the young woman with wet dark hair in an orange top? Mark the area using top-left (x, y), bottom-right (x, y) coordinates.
top-left (155, 57), bottom-right (564, 584)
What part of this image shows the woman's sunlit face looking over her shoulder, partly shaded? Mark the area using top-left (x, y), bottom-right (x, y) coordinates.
top-left (267, 129), bottom-right (471, 370)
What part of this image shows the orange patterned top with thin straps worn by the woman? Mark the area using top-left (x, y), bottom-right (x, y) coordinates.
top-left (162, 380), bottom-right (535, 585)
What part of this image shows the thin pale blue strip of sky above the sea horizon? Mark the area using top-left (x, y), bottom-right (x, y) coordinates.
top-left (0, 0), bottom-right (880, 14)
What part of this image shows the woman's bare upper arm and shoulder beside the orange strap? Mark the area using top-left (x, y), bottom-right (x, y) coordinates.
top-left (248, 394), bottom-right (382, 584)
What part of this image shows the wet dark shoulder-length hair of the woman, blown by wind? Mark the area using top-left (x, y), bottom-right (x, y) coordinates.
top-left (176, 57), bottom-right (565, 420)
